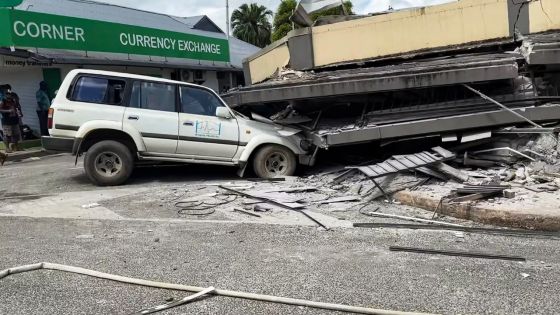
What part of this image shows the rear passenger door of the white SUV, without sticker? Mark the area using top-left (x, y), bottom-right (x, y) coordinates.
top-left (123, 81), bottom-right (179, 154)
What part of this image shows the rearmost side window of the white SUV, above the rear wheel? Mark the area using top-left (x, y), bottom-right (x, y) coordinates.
top-left (72, 76), bottom-right (126, 105)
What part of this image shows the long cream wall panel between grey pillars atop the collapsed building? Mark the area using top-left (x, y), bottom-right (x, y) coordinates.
top-left (312, 0), bottom-right (510, 67)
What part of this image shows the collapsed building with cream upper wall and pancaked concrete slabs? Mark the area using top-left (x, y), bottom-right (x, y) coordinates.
top-left (224, 0), bottom-right (560, 149)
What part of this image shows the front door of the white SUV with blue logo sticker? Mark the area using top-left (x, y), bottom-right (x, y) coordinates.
top-left (177, 85), bottom-right (239, 160)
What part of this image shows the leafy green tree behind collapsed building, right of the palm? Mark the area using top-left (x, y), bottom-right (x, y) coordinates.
top-left (272, 0), bottom-right (354, 41)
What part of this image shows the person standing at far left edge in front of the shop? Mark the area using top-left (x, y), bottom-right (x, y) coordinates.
top-left (0, 85), bottom-right (21, 153)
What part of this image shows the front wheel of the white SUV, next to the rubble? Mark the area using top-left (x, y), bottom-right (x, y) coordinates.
top-left (253, 145), bottom-right (297, 178)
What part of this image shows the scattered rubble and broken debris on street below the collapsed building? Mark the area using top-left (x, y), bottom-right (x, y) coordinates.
top-left (97, 129), bottom-right (560, 230)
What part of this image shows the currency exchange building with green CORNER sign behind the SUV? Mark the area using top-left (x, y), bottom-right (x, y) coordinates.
top-left (0, 0), bottom-right (259, 135)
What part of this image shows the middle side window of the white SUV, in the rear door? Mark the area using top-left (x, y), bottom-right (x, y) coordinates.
top-left (130, 81), bottom-right (176, 112)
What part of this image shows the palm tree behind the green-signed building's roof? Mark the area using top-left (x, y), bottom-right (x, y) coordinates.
top-left (231, 3), bottom-right (272, 48)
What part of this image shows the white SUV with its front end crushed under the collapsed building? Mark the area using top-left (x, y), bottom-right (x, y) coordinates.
top-left (42, 69), bottom-right (313, 186)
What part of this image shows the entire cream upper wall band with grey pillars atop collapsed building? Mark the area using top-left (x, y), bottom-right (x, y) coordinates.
top-left (244, 0), bottom-right (560, 84)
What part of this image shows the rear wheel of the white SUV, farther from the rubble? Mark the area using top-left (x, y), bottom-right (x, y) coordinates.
top-left (84, 140), bottom-right (134, 186)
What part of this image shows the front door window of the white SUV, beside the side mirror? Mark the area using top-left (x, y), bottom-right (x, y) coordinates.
top-left (181, 86), bottom-right (224, 116)
